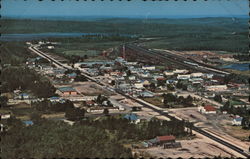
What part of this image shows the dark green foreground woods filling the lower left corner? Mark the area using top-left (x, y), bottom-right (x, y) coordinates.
top-left (1, 116), bottom-right (187, 159)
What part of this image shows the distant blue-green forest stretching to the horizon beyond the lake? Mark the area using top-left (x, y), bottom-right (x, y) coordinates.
top-left (2, 18), bottom-right (248, 53)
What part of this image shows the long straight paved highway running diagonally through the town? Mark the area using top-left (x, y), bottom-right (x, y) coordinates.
top-left (29, 45), bottom-right (250, 158)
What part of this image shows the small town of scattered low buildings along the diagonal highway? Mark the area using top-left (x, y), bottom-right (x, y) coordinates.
top-left (1, 41), bottom-right (250, 157)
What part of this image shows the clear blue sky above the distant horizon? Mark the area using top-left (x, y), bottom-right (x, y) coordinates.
top-left (1, 0), bottom-right (249, 18)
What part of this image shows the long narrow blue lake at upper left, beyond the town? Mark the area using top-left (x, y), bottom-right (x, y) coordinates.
top-left (0, 32), bottom-right (137, 41)
